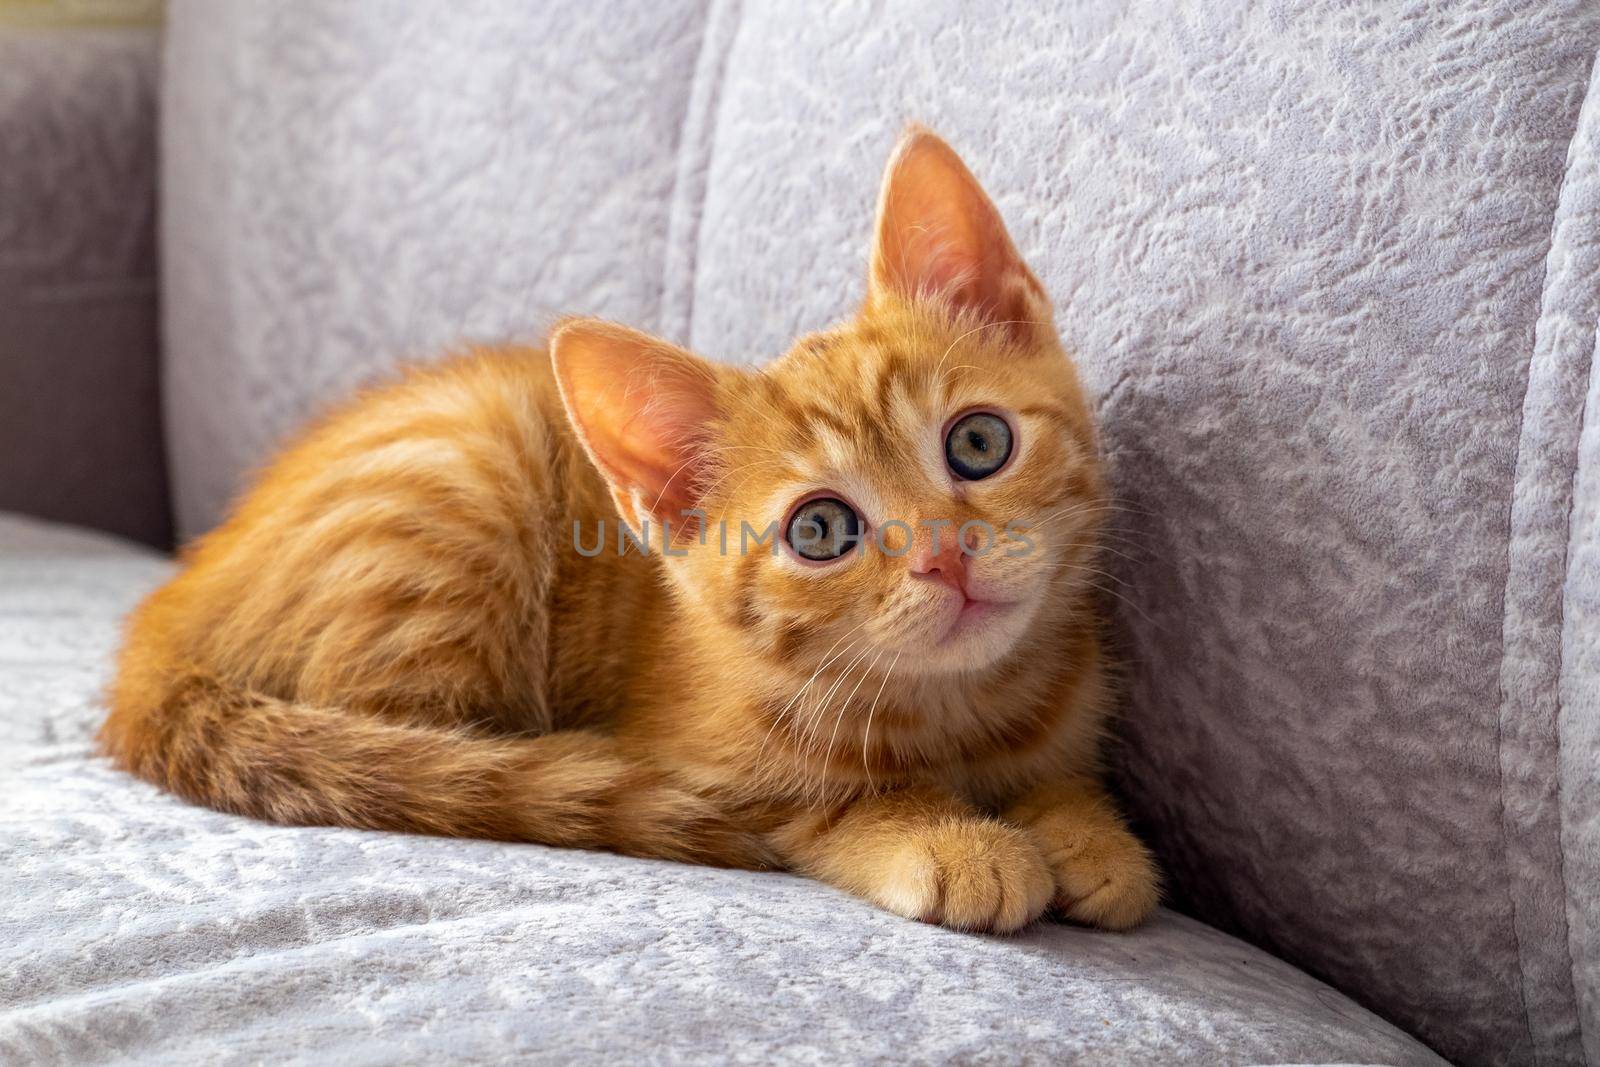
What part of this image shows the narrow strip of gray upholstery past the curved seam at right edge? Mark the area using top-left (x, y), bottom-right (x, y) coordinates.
top-left (1499, 56), bottom-right (1600, 1062)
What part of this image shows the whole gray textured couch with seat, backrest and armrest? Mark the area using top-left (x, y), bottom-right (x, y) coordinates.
top-left (0, 0), bottom-right (1600, 1065)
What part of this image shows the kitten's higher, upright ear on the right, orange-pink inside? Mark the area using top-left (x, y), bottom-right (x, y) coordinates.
top-left (867, 126), bottom-right (1051, 339)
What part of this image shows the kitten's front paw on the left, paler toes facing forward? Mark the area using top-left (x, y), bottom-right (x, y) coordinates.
top-left (877, 819), bottom-right (1056, 933)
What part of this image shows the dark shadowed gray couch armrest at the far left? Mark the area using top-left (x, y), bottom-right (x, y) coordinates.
top-left (0, 26), bottom-right (171, 544)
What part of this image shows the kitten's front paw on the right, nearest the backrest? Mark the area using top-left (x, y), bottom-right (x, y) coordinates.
top-left (1035, 827), bottom-right (1162, 929)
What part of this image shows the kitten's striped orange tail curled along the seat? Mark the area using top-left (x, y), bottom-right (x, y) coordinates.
top-left (99, 675), bottom-right (768, 867)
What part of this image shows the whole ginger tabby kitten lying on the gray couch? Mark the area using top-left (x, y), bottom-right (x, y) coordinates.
top-left (101, 130), bottom-right (1157, 931)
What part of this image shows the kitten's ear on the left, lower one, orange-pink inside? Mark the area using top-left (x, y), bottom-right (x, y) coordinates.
top-left (550, 318), bottom-right (718, 530)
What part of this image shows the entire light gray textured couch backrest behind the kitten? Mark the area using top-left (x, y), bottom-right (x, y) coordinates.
top-left (163, 0), bottom-right (1600, 1064)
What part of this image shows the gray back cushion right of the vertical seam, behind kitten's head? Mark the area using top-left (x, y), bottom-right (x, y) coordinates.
top-left (681, 0), bottom-right (1600, 1064)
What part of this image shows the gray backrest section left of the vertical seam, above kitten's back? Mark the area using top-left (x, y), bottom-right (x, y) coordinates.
top-left (162, 0), bottom-right (720, 536)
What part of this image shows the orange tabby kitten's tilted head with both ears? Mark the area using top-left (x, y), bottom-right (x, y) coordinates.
top-left (552, 130), bottom-right (1104, 673)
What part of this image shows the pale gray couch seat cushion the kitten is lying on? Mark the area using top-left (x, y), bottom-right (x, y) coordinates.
top-left (0, 515), bottom-right (1442, 1064)
